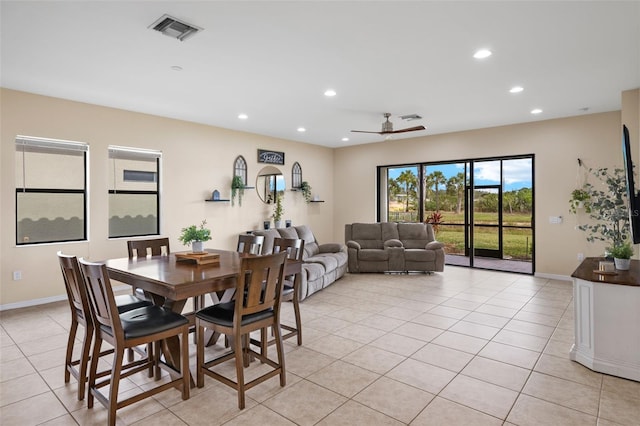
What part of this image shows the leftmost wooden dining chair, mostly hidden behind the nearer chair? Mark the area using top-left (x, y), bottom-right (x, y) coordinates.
top-left (57, 251), bottom-right (153, 401)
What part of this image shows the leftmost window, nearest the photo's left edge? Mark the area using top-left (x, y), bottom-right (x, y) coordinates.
top-left (16, 136), bottom-right (89, 245)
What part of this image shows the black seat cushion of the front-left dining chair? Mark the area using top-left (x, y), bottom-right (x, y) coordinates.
top-left (100, 305), bottom-right (189, 339)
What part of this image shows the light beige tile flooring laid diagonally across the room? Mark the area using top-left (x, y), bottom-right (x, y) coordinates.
top-left (0, 266), bottom-right (640, 426)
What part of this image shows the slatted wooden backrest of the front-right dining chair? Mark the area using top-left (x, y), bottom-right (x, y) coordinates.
top-left (234, 252), bottom-right (287, 322)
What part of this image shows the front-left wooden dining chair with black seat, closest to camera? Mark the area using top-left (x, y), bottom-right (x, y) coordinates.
top-left (79, 259), bottom-right (191, 426)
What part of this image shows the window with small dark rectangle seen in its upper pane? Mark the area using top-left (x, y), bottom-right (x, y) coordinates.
top-left (109, 146), bottom-right (162, 238)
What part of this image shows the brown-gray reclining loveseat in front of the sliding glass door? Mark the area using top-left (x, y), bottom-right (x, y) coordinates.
top-left (345, 222), bottom-right (444, 273)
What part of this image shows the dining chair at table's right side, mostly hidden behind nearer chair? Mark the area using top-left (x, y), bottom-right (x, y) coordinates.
top-left (267, 238), bottom-right (304, 346)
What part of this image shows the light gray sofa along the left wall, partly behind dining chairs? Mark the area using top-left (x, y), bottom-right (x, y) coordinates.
top-left (253, 225), bottom-right (347, 300)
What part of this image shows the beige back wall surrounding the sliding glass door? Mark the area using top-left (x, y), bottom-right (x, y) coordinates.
top-left (334, 112), bottom-right (622, 276)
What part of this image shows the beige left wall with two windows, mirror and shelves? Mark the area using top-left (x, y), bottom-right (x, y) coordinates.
top-left (0, 89), bottom-right (333, 305)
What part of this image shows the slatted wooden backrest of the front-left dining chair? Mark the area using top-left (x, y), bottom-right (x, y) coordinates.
top-left (79, 259), bottom-right (124, 339)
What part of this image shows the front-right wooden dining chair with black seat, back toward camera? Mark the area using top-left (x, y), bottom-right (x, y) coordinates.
top-left (196, 252), bottom-right (286, 409)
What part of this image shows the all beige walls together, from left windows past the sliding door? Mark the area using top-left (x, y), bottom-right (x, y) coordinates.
top-left (0, 89), bottom-right (640, 305)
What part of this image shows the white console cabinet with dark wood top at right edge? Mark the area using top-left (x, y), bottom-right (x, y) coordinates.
top-left (569, 257), bottom-right (640, 381)
